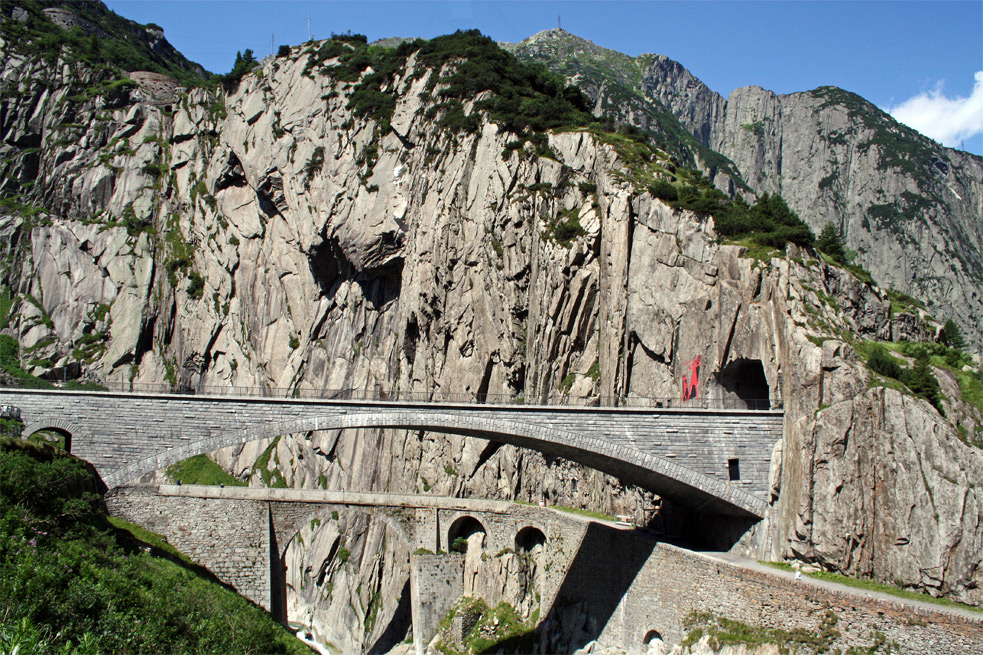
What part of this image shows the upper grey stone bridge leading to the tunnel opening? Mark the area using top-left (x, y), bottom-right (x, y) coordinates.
top-left (0, 389), bottom-right (784, 519)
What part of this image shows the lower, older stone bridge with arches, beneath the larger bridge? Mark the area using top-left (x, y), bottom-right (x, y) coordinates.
top-left (105, 485), bottom-right (590, 644)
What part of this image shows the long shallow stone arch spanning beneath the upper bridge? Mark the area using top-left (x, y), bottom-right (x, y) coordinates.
top-left (103, 410), bottom-right (767, 518)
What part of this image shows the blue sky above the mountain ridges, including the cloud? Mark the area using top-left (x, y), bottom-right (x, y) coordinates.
top-left (107, 0), bottom-right (983, 154)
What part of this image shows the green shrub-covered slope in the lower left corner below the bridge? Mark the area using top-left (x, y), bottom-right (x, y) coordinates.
top-left (0, 439), bottom-right (309, 653)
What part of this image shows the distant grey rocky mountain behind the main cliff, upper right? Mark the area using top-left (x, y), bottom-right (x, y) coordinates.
top-left (510, 30), bottom-right (983, 351)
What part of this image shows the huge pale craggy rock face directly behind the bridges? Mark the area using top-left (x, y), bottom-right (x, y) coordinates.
top-left (0, 6), bottom-right (983, 647)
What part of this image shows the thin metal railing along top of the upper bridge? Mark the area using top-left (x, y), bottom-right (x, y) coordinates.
top-left (0, 380), bottom-right (781, 410)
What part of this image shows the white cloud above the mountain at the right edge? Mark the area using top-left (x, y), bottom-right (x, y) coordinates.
top-left (887, 71), bottom-right (983, 148)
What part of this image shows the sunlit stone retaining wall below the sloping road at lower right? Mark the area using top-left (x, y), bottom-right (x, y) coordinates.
top-left (592, 535), bottom-right (983, 655)
